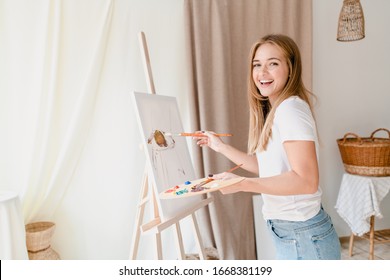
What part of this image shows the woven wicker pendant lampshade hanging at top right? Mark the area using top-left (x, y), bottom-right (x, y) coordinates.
top-left (337, 0), bottom-right (365, 42)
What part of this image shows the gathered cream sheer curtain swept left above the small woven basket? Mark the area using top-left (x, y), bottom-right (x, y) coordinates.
top-left (0, 1), bottom-right (113, 222)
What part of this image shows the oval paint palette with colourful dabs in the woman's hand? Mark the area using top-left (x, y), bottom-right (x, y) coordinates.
top-left (160, 177), bottom-right (244, 199)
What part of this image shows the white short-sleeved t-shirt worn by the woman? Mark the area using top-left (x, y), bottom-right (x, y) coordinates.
top-left (256, 96), bottom-right (322, 221)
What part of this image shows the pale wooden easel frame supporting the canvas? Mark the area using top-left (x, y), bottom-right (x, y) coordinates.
top-left (130, 32), bottom-right (213, 260)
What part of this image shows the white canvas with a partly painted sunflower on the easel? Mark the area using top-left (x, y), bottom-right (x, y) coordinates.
top-left (134, 92), bottom-right (202, 218)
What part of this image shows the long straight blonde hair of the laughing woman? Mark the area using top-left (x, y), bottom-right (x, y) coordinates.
top-left (248, 34), bottom-right (314, 154)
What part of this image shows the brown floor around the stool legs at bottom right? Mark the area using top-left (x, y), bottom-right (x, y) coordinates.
top-left (340, 236), bottom-right (390, 260)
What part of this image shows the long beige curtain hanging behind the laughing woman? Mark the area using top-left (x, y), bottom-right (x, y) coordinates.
top-left (184, 0), bottom-right (312, 259)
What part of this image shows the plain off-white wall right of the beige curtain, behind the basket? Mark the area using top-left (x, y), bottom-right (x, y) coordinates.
top-left (313, 0), bottom-right (390, 236)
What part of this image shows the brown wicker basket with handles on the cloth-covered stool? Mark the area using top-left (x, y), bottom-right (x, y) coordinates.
top-left (337, 128), bottom-right (390, 177)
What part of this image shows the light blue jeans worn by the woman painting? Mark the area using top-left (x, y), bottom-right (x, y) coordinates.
top-left (267, 207), bottom-right (341, 260)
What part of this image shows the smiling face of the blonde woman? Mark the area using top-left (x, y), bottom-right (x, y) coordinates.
top-left (252, 43), bottom-right (289, 105)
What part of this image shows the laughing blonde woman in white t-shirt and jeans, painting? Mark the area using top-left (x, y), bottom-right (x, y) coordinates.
top-left (196, 35), bottom-right (340, 259)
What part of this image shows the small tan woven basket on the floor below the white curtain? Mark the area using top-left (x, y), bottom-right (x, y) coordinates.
top-left (25, 222), bottom-right (60, 260)
